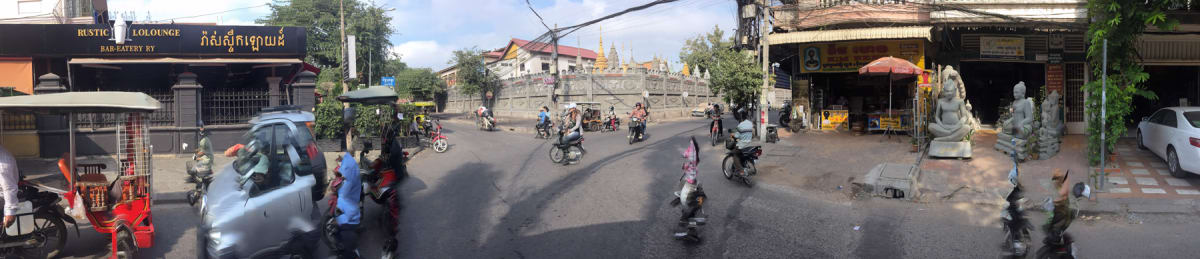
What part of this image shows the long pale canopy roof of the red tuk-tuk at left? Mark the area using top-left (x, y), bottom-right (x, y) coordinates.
top-left (0, 91), bottom-right (162, 114)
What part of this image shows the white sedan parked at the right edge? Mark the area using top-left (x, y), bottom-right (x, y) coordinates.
top-left (1138, 107), bottom-right (1200, 177)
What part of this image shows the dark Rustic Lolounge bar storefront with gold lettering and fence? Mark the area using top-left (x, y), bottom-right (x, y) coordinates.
top-left (0, 24), bottom-right (318, 157)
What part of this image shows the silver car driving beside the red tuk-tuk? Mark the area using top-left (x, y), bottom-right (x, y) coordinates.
top-left (197, 109), bottom-right (325, 258)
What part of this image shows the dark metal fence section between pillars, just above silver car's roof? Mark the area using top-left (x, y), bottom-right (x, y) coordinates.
top-left (200, 89), bottom-right (270, 125)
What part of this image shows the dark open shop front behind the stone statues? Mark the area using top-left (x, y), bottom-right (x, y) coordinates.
top-left (936, 26), bottom-right (1087, 134)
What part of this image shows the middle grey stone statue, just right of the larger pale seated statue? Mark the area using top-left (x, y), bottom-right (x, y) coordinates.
top-left (996, 82), bottom-right (1033, 159)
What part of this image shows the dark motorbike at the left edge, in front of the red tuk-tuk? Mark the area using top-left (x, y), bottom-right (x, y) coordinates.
top-left (0, 180), bottom-right (75, 258)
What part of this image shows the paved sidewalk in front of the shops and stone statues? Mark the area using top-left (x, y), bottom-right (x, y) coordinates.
top-left (758, 131), bottom-right (1200, 215)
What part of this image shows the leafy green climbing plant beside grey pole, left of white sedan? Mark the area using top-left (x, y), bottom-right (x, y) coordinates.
top-left (1084, 0), bottom-right (1178, 164)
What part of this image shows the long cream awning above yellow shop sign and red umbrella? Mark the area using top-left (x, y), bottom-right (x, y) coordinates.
top-left (767, 26), bottom-right (934, 44)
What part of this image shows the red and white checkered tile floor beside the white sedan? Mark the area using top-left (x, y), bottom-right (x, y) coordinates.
top-left (1102, 139), bottom-right (1200, 199)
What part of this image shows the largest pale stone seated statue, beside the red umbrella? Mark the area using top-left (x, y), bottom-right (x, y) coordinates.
top-left (929, 66), bottom-right (974, 158)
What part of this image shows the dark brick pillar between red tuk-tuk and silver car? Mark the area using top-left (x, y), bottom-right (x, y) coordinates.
top-left (167, 72), bottom-right (204, 153)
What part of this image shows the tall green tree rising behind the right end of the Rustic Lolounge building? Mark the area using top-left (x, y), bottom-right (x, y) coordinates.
top-left (256, 0), bottom-right (394, 83)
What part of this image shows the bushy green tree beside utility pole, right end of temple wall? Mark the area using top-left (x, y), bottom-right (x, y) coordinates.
top-left (708, 48), bottom-right (762, 103)
